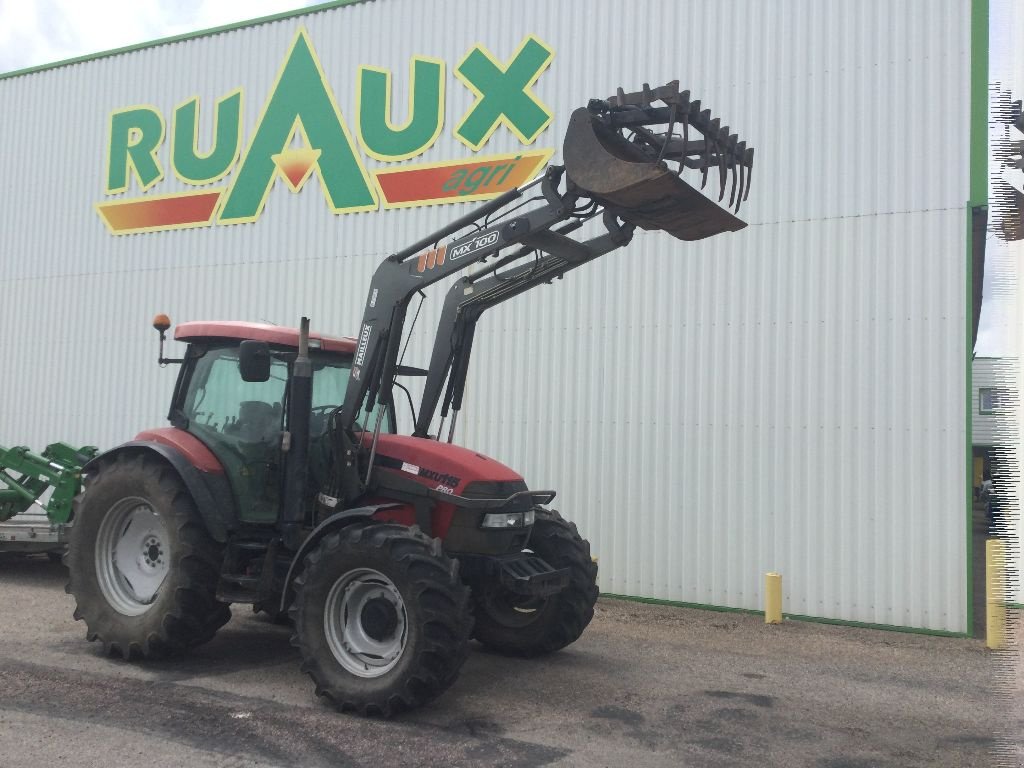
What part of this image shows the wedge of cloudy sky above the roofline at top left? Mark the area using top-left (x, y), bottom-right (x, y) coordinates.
top-left (0, 0), bottom-right (316, 73)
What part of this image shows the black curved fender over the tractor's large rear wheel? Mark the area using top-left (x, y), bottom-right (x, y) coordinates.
top-left (82, 440), bottom-right (238, 544)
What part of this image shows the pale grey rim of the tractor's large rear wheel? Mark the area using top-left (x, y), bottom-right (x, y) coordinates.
top-left (96, 498), bottom-right (170, 616)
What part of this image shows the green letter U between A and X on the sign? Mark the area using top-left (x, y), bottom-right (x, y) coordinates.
top-left (356, 56), bottom-right (444, 162)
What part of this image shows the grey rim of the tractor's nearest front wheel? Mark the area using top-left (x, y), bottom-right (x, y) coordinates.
top-left (324, 568), bottom-right (409, 678)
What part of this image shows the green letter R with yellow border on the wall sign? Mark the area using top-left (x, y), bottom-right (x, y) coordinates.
top-left (106, 106), bottom-right (164, 195)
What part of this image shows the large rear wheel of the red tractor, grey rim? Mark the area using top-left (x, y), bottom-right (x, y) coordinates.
top-left (65, 454), bottom-right (231, 659)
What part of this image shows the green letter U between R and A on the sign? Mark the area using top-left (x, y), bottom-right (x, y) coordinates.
top-left (171, 90), bottom-right (242, 184)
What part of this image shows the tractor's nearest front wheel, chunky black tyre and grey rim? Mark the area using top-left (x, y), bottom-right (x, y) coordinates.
top-left (290, 523), bottom-right (473, 717)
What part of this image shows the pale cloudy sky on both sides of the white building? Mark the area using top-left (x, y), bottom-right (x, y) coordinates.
top-left (0, 0), bottom-right (1024, 356)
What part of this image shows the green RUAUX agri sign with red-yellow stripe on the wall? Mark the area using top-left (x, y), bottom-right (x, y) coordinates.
top-left (96, 29), bottom-right (554, 234)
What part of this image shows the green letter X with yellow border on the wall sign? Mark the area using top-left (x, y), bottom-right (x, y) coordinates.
top-left (455, 36), bottom-right (554, 152)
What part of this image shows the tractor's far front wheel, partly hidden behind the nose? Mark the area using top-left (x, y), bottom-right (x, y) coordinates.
top-left (473, 510), bottom-right (598, 656)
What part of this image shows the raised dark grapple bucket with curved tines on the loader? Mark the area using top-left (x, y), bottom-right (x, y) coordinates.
top-left (562, 81), bottom-right (754, 241)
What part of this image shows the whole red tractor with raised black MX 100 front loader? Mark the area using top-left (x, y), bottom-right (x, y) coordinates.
top-left (61, 82), bottom-right (753, 716)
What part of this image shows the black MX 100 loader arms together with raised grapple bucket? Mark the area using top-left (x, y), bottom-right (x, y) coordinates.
top-left (328, 81), bottom-right (754, 503)
